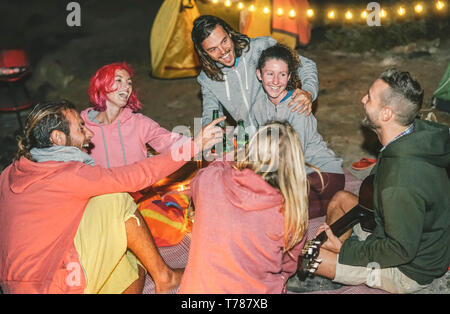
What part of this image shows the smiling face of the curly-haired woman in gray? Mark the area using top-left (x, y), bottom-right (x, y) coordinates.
top-left (256, 59), bottom-right (290, 105)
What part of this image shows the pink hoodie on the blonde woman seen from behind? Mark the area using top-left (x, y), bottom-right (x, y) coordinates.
top-left (179, 161), bottom-right (304, 294)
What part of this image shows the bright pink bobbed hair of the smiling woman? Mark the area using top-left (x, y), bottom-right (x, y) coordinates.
top-left (88, 62), bottom-right (142, 112)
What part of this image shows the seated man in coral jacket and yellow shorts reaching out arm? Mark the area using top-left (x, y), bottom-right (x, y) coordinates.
top-left (0, 101), bottom-right (223, 293)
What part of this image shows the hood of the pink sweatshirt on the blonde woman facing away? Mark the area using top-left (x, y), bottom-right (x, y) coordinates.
top-left (218, 163), bottom-right (283, 211)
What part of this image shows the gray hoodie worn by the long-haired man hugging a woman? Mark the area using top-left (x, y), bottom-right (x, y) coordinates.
top-left (197, 37), bottom-right (319, 128)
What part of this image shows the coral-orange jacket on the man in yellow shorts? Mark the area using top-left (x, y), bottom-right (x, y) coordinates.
top-left (0, 144), bottom-right (195, 293)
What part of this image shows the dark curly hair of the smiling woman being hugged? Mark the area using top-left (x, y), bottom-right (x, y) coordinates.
top-left (257, 43), bottom-right (301, 90)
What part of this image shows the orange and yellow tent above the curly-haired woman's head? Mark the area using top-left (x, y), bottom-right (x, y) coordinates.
top-left (240, 0), bottom-right (311, 49)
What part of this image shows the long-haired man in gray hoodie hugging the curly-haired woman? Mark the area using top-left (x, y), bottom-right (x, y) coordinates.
top-left (191, 15), bottom-right (319, 133)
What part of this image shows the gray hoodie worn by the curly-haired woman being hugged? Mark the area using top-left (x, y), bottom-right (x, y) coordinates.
top-left (253, 88), bottom-right (344, 174)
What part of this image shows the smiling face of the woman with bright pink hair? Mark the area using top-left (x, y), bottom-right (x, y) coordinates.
top-left (106, 69), bottom-right (133, 108)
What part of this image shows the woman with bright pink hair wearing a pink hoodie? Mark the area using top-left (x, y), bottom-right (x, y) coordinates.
top-left (81, 62), bottom-right (188, 168)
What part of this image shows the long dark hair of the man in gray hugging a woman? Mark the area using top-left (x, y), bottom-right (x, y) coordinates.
top-left (191, 15), bottom-right (250, 81)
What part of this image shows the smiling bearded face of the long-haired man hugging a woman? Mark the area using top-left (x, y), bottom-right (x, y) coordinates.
top-left (202, 25), bottom-right (236, 67)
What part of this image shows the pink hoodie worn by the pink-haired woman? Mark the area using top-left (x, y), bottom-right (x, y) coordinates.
top-left (81, 108), bottom-right (187, 168)
